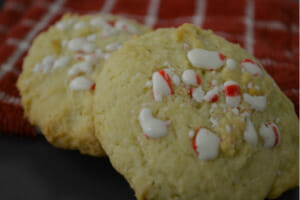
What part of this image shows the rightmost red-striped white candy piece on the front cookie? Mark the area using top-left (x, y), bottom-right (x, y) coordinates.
top-left (259, 122), bottom-right (280, 148)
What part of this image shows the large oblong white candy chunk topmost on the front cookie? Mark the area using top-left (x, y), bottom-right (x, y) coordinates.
top-left (187, 49), bottom-right (224, 69)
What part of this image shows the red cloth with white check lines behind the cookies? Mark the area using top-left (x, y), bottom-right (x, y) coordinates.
top-left (0, 0), bottom-right (299, 136)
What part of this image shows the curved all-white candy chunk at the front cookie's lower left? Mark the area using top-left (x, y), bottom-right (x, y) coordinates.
top-left (139, 108), bottom-right (169, 138)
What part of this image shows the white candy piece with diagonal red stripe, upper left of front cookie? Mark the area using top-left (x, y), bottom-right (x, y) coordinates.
top-left (152, 70), bottom-right (174, 101)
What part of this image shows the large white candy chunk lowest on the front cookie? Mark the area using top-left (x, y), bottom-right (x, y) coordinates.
top-left (194, 128), bottom-right (220, 160)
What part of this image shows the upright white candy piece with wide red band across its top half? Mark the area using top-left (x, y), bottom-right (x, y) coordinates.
top-left (224, 81), bottom-right (241, 108)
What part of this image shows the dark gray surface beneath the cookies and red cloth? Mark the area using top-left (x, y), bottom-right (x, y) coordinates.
top-left (0, 134), bottom-right (299, 200)
